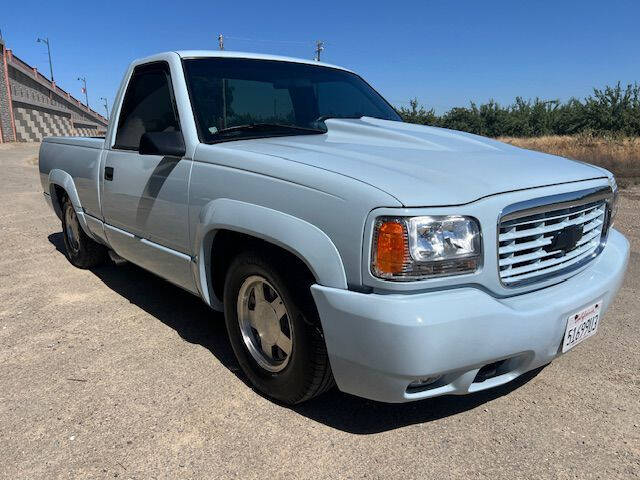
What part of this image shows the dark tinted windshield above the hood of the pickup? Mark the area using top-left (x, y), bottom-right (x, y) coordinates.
top-left (184, 58), bottom-right (401, 143)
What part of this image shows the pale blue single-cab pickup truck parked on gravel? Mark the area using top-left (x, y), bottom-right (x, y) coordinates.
top-left (40, 51), bottom-right (629, 404)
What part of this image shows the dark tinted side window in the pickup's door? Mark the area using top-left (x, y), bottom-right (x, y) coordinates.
top-left (114, 64), bottom-right (180, 150)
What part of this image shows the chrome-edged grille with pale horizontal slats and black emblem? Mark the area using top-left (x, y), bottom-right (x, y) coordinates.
top-left (498, 195), bottom-right (607, 287)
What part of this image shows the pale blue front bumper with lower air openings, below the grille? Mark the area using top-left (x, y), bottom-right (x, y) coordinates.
top-left (311, 229), bottom-right (629, 402)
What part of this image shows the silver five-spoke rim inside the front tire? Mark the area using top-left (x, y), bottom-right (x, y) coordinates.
top-left (237, 275), bottom-right (293, 372)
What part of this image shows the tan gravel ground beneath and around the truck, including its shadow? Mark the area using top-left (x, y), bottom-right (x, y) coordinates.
top-left (0, 144), bottom-right (640, 479)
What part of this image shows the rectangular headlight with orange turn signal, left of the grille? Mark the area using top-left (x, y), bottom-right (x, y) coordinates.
top-left (371, 216), bottom-right (482, 281)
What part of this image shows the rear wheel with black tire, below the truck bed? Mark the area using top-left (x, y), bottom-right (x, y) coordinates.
top-left (62, 198), bottom-right (107, 268)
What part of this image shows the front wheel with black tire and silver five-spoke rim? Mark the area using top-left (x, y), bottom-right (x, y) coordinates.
top-left (224, 252), bottom-right (334, 405)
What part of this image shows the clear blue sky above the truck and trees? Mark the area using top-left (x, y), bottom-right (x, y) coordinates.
top-left (0, 0), bottom-right (640, 112)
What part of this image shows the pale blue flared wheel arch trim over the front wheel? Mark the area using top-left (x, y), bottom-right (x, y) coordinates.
top-left (193, 198), bottom-right (347, 307)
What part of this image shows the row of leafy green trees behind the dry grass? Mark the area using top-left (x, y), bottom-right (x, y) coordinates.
top-left (398, 83), bottom-right (640, 137)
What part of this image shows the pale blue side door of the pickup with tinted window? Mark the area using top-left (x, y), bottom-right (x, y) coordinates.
top-left (102, 62), bottom-right (193, 290)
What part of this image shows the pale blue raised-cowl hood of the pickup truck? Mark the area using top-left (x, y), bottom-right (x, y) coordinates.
top-left (225, 117), bottom-right (606, 207)
